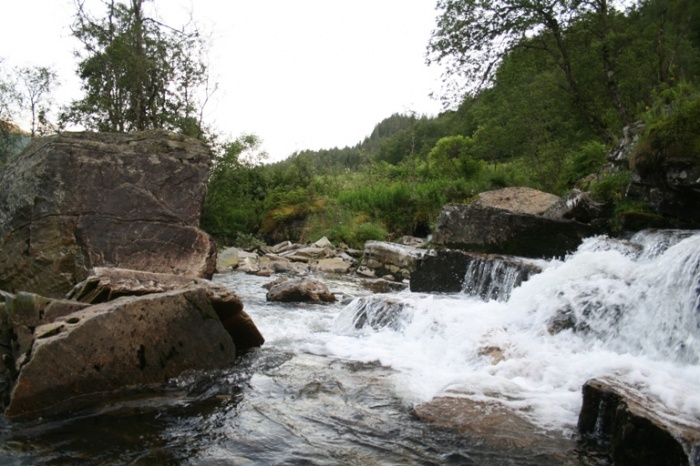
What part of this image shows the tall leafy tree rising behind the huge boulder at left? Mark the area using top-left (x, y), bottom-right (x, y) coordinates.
top-left (61, 0), bottom-right (209, 137)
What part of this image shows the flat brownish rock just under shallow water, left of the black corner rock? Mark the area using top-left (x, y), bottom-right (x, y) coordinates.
top-left (415, 397), bottom-right (575, 458)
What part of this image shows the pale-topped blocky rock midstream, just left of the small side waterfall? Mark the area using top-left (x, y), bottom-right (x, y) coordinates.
top-left (358, 241), bottom-right (426, 280)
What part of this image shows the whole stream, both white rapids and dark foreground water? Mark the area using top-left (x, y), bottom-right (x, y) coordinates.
top-left (0, 232), bottom-right (700, 465)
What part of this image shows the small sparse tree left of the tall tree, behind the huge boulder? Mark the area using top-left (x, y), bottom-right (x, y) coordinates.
top-left (17, 66), bottom-right (56, 137)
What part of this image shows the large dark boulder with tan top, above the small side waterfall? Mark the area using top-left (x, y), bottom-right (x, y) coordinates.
top-left (433, 190), bottom-right (598, 258)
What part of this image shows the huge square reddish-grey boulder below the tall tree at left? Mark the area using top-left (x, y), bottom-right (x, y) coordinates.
top-left (0, 131), bottom-right (216, 296)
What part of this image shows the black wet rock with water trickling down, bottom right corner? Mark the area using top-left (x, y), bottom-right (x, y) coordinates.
top-left (578, 379), bottom-right (700, 466)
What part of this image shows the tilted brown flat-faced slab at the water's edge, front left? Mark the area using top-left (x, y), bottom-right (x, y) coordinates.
top-left (5, 286), bottom-right (241, 417)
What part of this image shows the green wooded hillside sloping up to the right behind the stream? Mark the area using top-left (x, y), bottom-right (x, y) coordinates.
top-left (203, 0), bottom-right (700, 246)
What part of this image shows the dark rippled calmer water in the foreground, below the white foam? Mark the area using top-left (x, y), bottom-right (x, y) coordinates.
top-left (0, 348), bottom-right (583, 465)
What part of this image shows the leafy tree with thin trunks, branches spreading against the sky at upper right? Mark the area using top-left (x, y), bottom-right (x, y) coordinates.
top-left (428, 0), bottom-right (628, 140)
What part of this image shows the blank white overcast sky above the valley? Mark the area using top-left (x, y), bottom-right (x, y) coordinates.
top-left (0, 0), bottom-right (441, 161)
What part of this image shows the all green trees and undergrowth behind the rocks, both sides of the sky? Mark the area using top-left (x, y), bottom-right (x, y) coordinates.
top-left (0, 0), bottom-right (700, 247)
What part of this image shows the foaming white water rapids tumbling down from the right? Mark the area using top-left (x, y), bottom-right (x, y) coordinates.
top-left (246, 232), bottom-right (700, 431)
